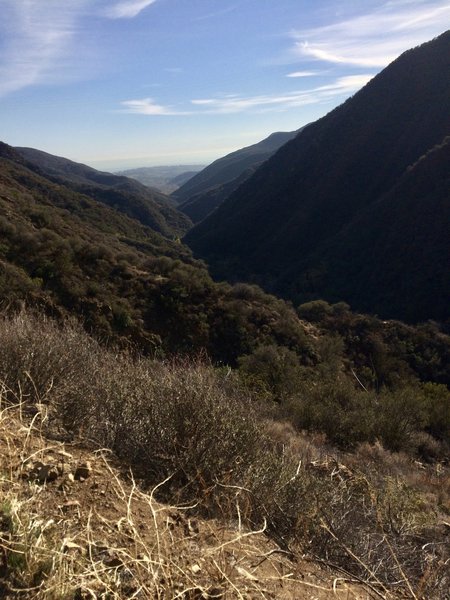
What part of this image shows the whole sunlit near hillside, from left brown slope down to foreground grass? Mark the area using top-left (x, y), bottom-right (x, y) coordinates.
top-left (0, 144), bottom-right (450, 600)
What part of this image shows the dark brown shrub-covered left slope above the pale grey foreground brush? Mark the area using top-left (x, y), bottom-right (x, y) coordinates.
top-left (0, 143), bottom-right (309, 364)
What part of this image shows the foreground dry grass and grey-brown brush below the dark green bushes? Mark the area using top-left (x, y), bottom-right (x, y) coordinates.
top-left (0, 315), bottom-right (450, 600)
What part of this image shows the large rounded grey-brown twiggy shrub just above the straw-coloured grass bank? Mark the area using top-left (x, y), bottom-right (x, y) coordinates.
top-left (63, 357), bottom-right (261, 500)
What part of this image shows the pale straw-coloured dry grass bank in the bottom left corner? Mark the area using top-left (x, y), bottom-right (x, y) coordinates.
top-left (0, 398), bottom-right (380, 600)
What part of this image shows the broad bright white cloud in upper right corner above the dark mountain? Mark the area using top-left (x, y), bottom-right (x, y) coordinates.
top-left (292, 0), bottom-right (450, 68)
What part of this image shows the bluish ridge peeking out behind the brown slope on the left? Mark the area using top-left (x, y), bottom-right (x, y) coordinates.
top-left (16, 148), bottom-right (190, 237)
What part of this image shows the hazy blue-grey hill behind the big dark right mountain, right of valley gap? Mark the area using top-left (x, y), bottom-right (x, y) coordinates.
top-left (172, 130), bottom-right (300, 223)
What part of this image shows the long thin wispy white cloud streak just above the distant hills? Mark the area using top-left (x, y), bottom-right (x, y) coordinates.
top-left (122, 74), bottom-right (373, 116)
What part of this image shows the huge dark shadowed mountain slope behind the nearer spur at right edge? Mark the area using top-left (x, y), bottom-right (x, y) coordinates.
top-left (185, 32), bottom-right (450, 319)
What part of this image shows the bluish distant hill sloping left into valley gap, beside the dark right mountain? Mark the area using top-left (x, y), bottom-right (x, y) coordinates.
top-left (172, 131), bottom-right (297, 216)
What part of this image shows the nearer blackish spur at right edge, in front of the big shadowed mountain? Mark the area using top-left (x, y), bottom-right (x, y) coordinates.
top-left (306, 138), bottom-right (450, 321)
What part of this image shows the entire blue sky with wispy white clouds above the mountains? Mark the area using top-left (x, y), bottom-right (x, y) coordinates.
top-left (0, 0), bottom-right (450, 170)
